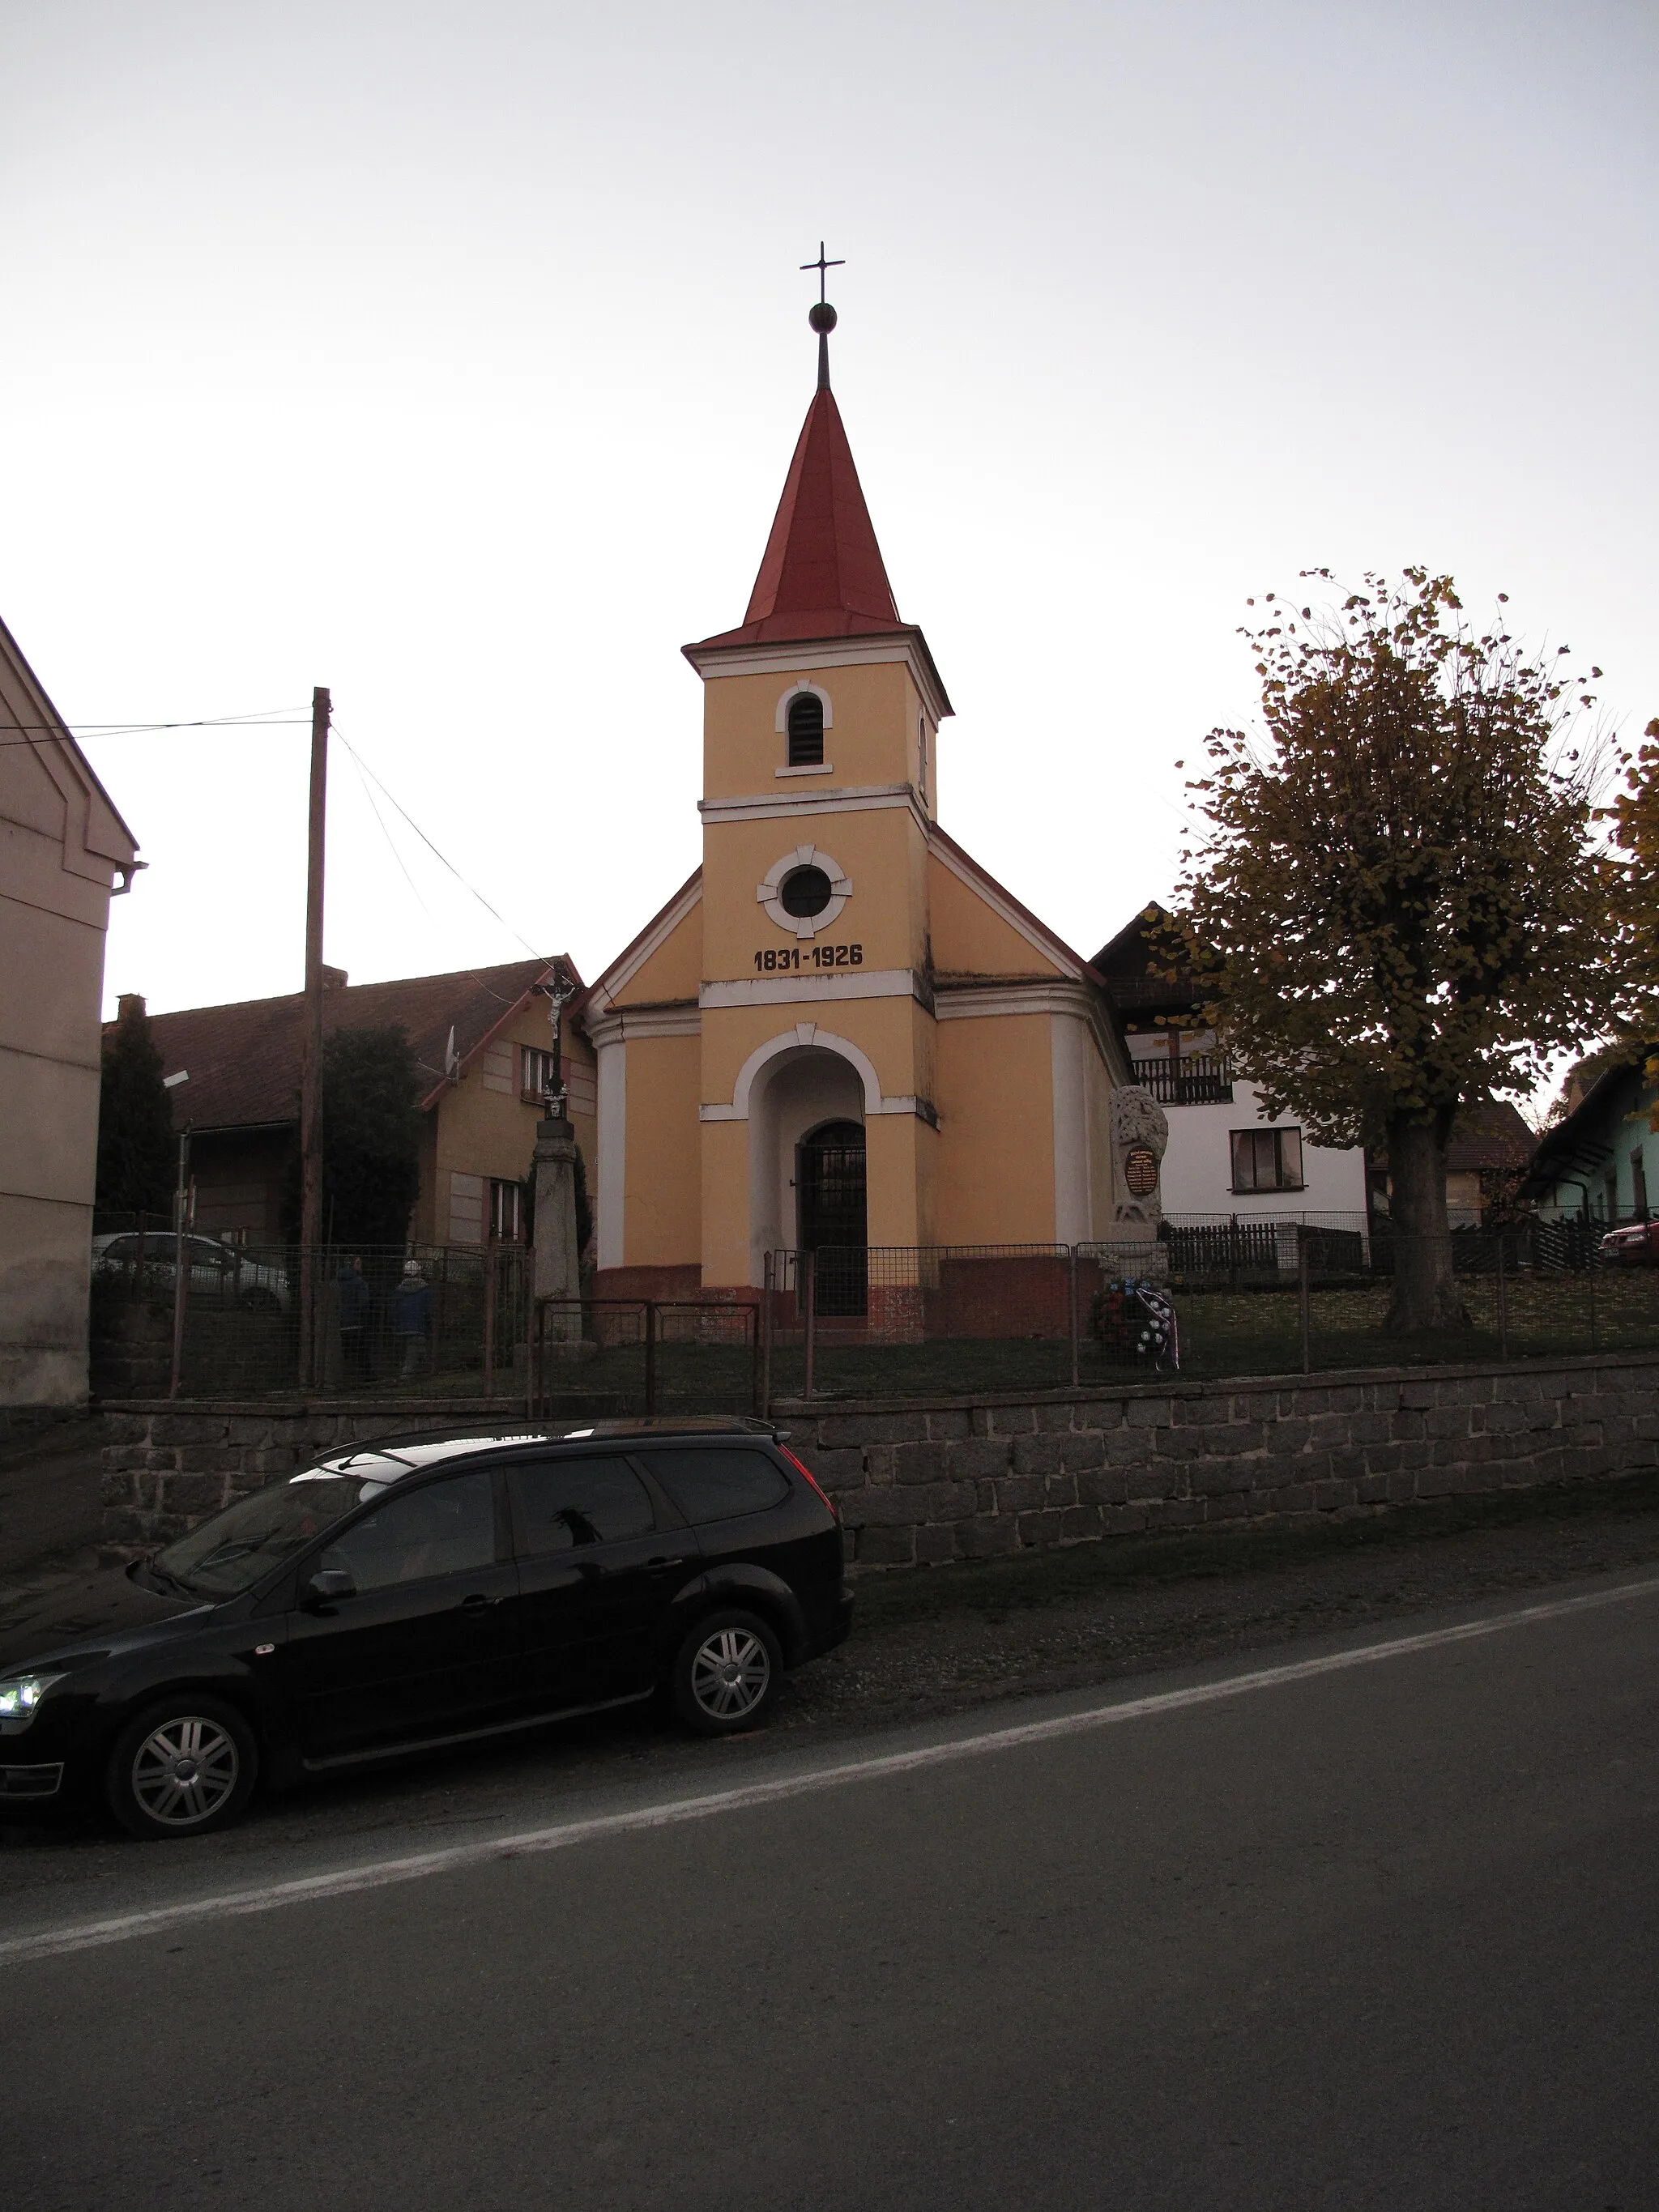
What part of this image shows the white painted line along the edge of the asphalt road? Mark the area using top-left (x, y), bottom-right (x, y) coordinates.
top-left (0, 1575), bottom-right (1659, 1967)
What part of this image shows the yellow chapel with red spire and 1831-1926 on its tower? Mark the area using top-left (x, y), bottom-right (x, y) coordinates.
top-left (578, 285), bottom-right (1139, 1319)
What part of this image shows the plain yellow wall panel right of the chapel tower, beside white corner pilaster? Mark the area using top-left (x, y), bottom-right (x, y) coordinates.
top-left (933, 1013), bottom-right (1056, 1246)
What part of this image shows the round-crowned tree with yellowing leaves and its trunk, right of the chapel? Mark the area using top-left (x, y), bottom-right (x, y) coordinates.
top-left (1179, 569), bottom-right (1618, 1332)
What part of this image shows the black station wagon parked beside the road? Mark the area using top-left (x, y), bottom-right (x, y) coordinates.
top-left (0, 1420), bottom-right (851, 1836)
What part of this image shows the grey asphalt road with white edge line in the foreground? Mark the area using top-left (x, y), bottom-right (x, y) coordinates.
top-left (0, 1577), bottom-right (1659, 2212)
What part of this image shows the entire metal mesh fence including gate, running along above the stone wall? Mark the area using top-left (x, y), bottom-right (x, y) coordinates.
top-left (93, 1217), bottom-right (1659, 1416)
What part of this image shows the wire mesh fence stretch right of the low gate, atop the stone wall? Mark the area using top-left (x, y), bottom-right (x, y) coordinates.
top-left (761, 1217), bottom-right (1659, 1404)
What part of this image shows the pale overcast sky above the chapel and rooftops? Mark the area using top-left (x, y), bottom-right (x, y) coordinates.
top-left (0, 0), bottom-right (1659, 1008)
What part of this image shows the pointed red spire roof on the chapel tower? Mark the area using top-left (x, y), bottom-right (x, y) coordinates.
top-left (702, 385), bottom-right (907, 646)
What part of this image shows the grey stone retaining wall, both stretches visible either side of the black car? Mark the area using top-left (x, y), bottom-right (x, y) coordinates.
top-left (102, 1353), bottom-right (1659, 1566)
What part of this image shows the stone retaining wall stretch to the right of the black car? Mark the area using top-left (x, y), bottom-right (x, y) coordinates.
top-left (776, 1353), bottom-right (1659, 1566)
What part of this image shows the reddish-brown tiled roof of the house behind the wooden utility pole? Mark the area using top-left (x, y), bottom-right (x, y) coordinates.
top-left (118, 960), bottom-right (575, 1131)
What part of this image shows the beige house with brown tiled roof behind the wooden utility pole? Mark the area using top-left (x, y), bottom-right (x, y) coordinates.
top-left (125, 958), bottom-right (595, 1246)
